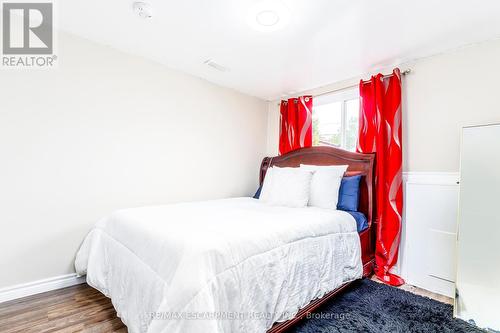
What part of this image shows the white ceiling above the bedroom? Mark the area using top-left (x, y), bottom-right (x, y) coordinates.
top-left (57, 0), bottom-right (500, 100)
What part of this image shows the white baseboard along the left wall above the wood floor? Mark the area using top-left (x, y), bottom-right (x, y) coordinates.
top-left (0, 273), bottom-right (85, 303)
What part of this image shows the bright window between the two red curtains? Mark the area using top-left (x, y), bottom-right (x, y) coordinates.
top-left (312, 90), bottom-right (359, 151)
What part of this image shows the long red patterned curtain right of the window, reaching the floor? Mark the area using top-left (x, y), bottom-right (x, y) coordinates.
top-left (358, 68), bottom-right (404, 286)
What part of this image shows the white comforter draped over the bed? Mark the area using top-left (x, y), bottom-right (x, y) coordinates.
top-left (75, 198), bottom-right (362, 333)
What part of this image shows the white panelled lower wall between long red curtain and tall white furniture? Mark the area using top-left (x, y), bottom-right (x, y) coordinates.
top-left (395, 172), bottom-right (460, 297)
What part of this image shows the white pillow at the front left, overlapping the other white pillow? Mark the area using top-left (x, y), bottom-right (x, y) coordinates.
top-left (259, 167), bottom-right (313, 207)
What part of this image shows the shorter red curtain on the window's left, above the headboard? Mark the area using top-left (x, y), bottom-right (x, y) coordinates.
top-left (279, 96), bottom-right (312, 155)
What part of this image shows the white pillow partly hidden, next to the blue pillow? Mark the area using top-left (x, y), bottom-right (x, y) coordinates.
top-left (300, 164), bottom-right (347, 210)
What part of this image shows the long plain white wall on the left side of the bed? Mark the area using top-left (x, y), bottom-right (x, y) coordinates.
top-left (0, 34), bottom-right (267, 287)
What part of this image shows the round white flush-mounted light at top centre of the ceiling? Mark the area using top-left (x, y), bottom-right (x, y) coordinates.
top-left (247, 0), bottom-right (290, 32)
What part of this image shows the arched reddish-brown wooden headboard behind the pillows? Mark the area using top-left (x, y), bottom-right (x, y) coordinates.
top-left (259, 146), bottom-right (375, 226)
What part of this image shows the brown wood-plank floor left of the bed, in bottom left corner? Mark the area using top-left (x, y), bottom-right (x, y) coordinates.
top-left (0, 284), bottom-right (127, 333)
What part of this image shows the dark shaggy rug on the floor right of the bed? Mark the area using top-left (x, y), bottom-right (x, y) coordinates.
top-left (291, 279), bottom-right (484, 333)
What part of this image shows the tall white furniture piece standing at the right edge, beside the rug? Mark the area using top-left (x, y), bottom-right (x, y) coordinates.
top-left (454, 124), bottom-right (500, 331)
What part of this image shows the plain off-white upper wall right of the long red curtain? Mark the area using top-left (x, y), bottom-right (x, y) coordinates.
top-left (404, 40), bottom-right (500, 172)
